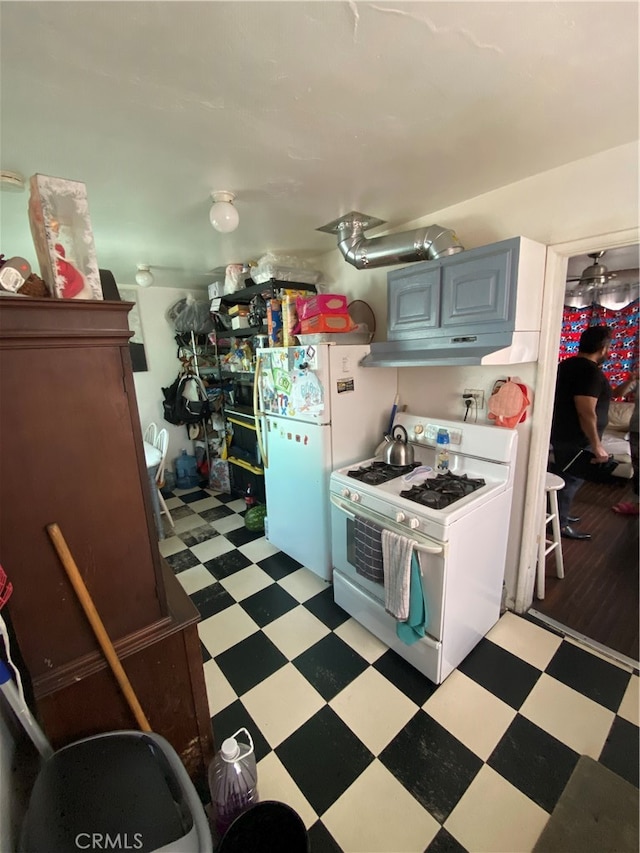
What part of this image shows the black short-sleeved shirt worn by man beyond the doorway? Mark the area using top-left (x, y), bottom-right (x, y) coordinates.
top-left (551, 355), bottom-right (611, 447)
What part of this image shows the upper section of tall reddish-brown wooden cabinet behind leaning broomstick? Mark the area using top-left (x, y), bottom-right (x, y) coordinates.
top-left (0, 299), bottom-right (166, 681)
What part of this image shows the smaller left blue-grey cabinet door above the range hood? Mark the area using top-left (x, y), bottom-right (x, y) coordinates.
top-left (387, 263), bottom-right (440, 340)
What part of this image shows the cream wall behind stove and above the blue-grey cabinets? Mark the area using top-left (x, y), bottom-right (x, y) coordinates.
top-left (316, 143), bottom-right (639, 606)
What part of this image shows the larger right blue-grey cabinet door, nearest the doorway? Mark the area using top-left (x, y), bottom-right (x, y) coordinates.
top-left (441, 248), bottom-right (515, 331)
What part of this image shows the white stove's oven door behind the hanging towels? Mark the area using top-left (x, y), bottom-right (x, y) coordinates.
top-left (331, 494), bottom-right (447, 645)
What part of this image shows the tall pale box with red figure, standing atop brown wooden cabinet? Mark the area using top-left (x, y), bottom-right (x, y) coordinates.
top-left (29, 174), bottom-right (103, 299)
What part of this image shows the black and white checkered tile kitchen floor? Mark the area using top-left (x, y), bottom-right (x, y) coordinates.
top-left (160, 489), bottom-right (638, 853)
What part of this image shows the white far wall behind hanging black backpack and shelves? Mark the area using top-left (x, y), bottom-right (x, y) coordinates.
top-left (119, 290), bottom-right (207, 468)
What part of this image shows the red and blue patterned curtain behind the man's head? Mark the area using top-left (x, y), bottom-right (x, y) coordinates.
top-left (559, 299), bottom-right (640, 388)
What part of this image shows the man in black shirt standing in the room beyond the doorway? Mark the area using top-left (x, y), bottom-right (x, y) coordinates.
top-left (551, 326), bottom-right (635, 539)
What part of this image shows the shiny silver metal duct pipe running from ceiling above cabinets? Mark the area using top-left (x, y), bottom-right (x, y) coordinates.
top-left (318, 211), bottom-right (464, 269)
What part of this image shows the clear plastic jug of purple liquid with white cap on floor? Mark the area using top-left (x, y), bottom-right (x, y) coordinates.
top-left (209, 729), bottom-right (258, 836)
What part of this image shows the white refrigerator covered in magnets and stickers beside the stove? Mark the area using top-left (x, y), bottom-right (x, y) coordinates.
top-left (254, 344), bottom-right (397, 580)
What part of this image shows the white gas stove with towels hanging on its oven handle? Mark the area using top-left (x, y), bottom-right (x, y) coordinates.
top-left (330, 413), bottom-right (517, 684)
